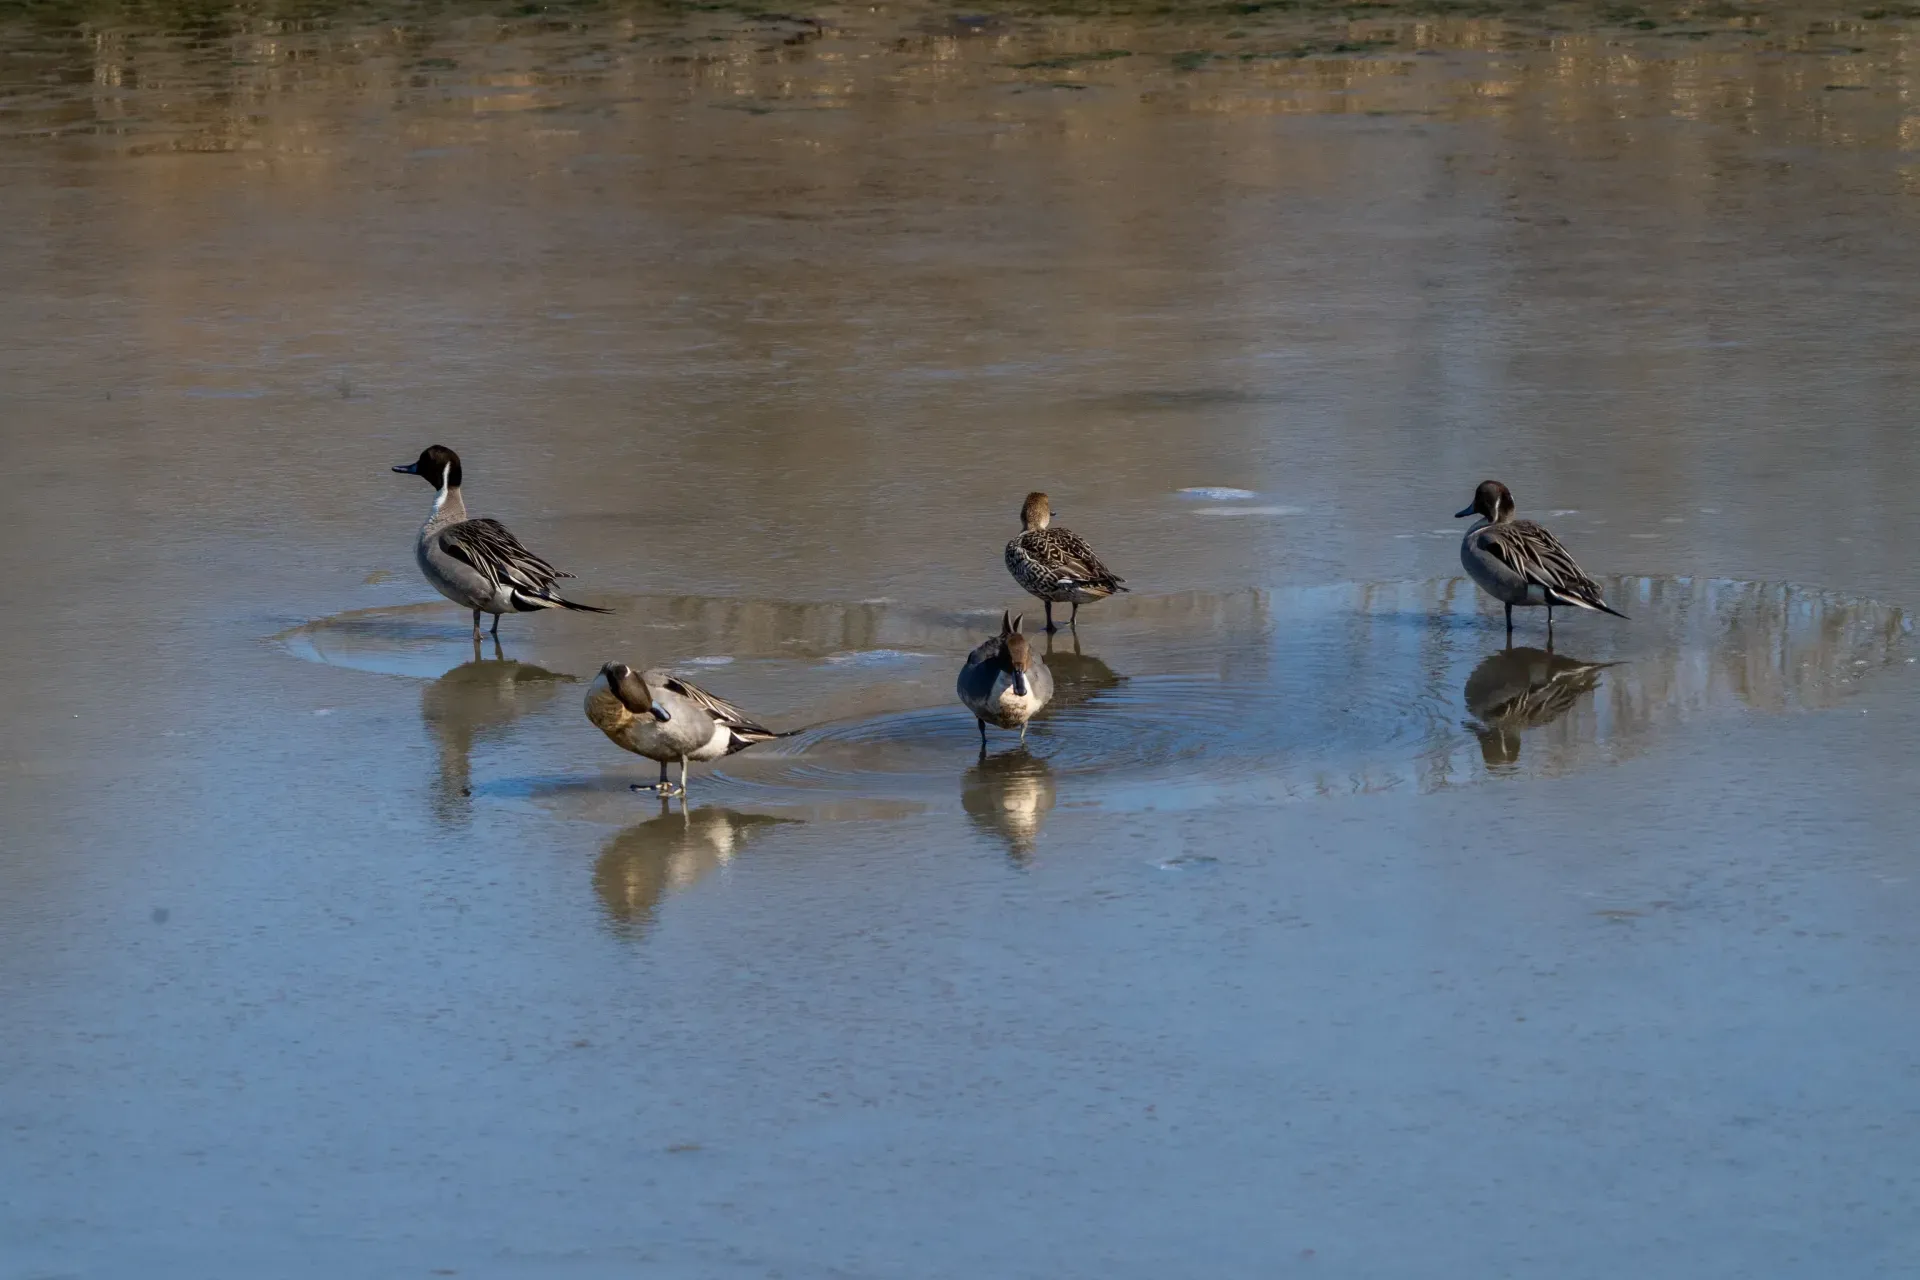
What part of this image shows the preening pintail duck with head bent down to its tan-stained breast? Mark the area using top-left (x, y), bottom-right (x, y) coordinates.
top-left (588, 662), bottom-right (799, 796)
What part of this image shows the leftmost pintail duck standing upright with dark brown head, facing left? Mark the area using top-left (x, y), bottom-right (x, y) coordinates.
top-left (394, 445), bottom-right (612, 641)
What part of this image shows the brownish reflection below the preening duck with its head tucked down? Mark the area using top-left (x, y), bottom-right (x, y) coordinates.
top-left (593, 798), bottom-right (801, 938)
